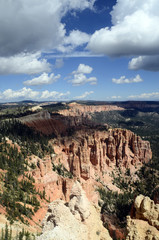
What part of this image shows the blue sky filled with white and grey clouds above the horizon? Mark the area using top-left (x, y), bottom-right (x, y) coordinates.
top-left (0, 0), bottom-right (159, 102)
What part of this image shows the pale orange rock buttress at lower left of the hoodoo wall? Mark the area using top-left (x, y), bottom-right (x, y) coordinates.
top-left (29, 156), bottom-right (74, 201)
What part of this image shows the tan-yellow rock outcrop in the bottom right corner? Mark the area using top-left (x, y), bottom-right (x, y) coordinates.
top-left (126, 195), bottom-right (159, 240)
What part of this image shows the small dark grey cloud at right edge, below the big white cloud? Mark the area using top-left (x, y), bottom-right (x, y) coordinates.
top-left (129, 55), bottom-right (159, 72)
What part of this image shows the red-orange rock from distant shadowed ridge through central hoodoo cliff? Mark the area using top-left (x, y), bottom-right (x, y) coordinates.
top-left (18, 104), bottom-right (152, 232)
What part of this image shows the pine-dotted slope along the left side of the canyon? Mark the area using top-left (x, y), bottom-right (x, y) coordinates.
top-left (0, 119), bottom-right (53, 223)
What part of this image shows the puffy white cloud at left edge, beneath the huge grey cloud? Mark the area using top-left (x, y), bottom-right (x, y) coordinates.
top-left (0, 52), bottom-right (51, 74)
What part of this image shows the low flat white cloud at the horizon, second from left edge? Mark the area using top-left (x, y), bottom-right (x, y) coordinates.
top-left (40, 90), bottom-right (70, 99)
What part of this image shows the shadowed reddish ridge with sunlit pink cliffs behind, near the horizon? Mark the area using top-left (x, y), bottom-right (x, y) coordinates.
top-left (19, 103), bottom-right (123, 136)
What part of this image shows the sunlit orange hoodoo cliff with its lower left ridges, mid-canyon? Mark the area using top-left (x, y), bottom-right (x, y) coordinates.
top-left (30, 126), bottom-right (152, 226)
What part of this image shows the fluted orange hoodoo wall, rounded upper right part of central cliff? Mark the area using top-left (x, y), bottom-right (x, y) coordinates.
top-left (54, 129), bottom-right (152, 181)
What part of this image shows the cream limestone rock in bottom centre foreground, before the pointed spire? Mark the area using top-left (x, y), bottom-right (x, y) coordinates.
top-left (38, 200), bottom-right (88, 240)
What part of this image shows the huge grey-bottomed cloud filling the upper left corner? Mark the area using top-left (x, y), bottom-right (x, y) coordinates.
top-left (0, 0), bottom-right (95, 57)
